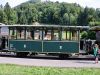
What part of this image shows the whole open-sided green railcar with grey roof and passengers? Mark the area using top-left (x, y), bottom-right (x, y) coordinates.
top-left (0, 25), bottom-right (89, 57)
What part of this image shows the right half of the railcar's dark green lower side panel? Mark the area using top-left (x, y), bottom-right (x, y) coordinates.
top-left (43, 41), bottom-right (79, 53)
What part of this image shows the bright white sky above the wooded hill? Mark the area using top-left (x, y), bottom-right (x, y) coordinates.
top-left (0, 0), bottom-right (100, 8)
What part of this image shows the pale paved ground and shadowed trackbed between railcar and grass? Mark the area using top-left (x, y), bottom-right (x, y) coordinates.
top-left (0, 55), bottom-right (100, 68)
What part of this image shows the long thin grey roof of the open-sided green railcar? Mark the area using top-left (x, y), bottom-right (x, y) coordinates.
top-left (0, 24), bottom-right (89, 29)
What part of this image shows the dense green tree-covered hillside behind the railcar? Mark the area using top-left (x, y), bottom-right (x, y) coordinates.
top-left (0, 0), bottom-right (100, 26)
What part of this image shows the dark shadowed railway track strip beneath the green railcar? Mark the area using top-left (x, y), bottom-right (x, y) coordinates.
top-left (0, 52), bottom-right (94, 60)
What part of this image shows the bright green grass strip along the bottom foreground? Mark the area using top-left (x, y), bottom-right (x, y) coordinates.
top-left (0, 64), bottom-right (100, 75)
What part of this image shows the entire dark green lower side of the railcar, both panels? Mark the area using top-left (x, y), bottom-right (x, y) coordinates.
top-left (9, 40), bottom-right (79, 53)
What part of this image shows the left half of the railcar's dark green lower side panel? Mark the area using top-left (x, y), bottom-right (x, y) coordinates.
top-left (9, 40), bottom-right (42, 52)
